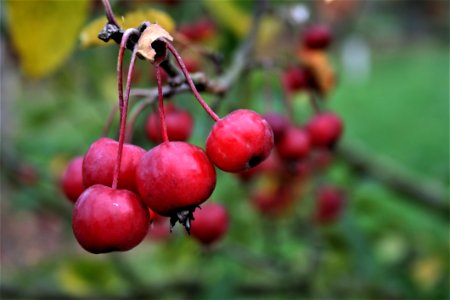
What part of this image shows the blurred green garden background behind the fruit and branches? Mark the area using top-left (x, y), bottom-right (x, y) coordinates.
top-left (0, 0), bottom-right (450, 299)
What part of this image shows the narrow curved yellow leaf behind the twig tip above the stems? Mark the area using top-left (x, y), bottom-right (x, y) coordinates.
top-left (80, 9), bottom-right (175, 47)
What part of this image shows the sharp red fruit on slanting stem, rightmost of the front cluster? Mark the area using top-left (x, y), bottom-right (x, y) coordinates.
top-left (206, 109), bottom-right (274, 173)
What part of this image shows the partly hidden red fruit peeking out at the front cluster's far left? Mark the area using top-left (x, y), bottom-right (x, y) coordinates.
top-left (62, 156), bottom-right (84, 203)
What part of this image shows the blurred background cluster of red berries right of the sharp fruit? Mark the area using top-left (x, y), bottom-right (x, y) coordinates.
top-left (239, 25), bottom-right (346, 223)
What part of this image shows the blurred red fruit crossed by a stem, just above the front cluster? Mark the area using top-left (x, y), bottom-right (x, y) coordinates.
top-left (145, 104), bottom-right (194, 144)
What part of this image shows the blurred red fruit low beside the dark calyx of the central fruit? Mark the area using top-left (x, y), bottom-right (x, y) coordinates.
top-left (191, 203), bottom-right (229, 245)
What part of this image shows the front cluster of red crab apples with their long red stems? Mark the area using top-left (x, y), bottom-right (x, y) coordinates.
top-left (63, 23), bottom-right (274, 253)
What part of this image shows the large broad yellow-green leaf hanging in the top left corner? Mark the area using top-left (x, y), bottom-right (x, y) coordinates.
top-left (6, 0), bottom-right (89, 78)
